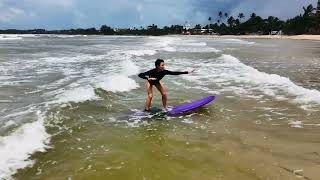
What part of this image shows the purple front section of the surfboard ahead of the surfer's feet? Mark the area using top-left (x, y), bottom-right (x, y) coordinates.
top-left (169, 96), bottom-right (216, 115)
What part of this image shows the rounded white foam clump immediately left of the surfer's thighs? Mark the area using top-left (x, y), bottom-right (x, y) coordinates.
top-left (96, 75), bottom-right (139, 93)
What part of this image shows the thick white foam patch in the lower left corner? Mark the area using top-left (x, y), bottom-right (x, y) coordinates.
top-left (0, 113), bottom-right (50, 179)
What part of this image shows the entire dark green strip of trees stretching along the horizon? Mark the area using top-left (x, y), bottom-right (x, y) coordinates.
top-left (0, 4), bottom-right (320, 36)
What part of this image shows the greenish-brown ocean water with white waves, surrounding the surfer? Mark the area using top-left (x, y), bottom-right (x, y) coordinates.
top-left (0, 35), bottom-right (320, 180)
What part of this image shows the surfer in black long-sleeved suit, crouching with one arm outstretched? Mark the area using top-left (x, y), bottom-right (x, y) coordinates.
top-left (138, 59), bottom-right (193, 111)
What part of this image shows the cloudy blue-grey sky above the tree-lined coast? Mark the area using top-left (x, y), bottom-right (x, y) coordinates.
top-left (0, 0), bottom-right (317, 30)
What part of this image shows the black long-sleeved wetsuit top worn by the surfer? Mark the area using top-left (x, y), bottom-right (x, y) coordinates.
top-left (138, 68), bottom-right (188, 85)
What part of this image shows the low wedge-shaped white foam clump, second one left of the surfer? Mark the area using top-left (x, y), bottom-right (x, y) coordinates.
top-left (51, 85), bottom-right (100, 104)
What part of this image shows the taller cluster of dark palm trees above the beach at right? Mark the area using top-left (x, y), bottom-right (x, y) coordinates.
top-left (205, 4), bottom-right (320, 35)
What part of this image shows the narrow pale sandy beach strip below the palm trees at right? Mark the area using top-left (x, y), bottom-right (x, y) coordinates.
top-left (191, 35), bottom-right (320, 41)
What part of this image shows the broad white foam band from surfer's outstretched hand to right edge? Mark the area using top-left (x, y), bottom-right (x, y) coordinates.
top-left (183, 54), bottom-right (320, 110)
